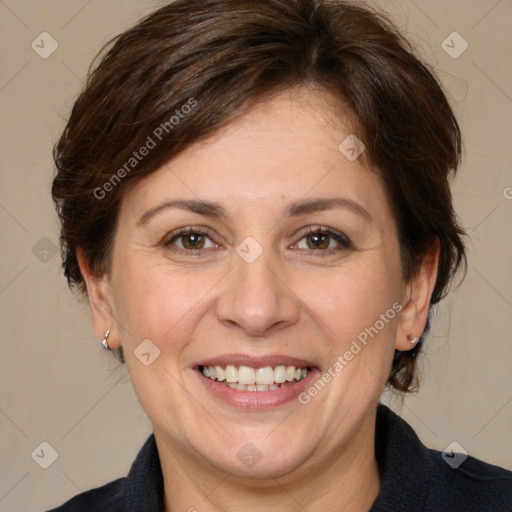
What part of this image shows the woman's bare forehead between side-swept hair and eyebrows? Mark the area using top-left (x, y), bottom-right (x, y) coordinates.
top-left (120, 87), bottom-right (387, 223)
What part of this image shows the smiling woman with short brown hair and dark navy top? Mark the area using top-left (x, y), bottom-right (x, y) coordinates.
top-left (47, 0), bottom-right (512, 512)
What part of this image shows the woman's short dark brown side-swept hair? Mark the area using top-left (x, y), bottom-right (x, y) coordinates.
top-left (52, 0), bottom-right (465, 391)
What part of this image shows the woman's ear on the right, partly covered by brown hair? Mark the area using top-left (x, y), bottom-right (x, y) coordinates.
top-left (395, 239), bottom-right (440, 351)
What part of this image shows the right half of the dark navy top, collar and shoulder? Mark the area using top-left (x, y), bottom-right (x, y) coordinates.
top-left (371, 404), bottom-right (512, 512)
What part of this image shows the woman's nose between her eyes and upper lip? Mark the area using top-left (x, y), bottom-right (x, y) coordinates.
top-left (216, 249), bottom-right (300, 336)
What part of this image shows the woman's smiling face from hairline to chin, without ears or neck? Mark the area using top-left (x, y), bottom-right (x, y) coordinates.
top-left (90, 89), bottom-right (420, 478)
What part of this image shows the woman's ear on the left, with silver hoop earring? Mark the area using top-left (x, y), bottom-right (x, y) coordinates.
top-left (76, 248), bottom-right (121, 349)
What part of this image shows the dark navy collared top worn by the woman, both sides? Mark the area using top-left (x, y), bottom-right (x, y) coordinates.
top-left (50, 404), bottom-right (512, 512)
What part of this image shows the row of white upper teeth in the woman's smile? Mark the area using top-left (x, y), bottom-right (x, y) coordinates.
top-left (203, 364), bottom-right (308, 385)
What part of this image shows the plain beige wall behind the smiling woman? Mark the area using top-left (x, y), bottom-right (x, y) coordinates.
top-left (0, 0), bottom-right (512, 512)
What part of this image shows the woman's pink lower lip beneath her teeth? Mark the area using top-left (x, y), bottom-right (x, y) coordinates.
top-left (196, 368), bottom-right (319, 409)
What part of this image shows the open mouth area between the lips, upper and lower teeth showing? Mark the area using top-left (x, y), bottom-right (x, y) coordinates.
top-left (198, 365), bottom-right (310, 391)
